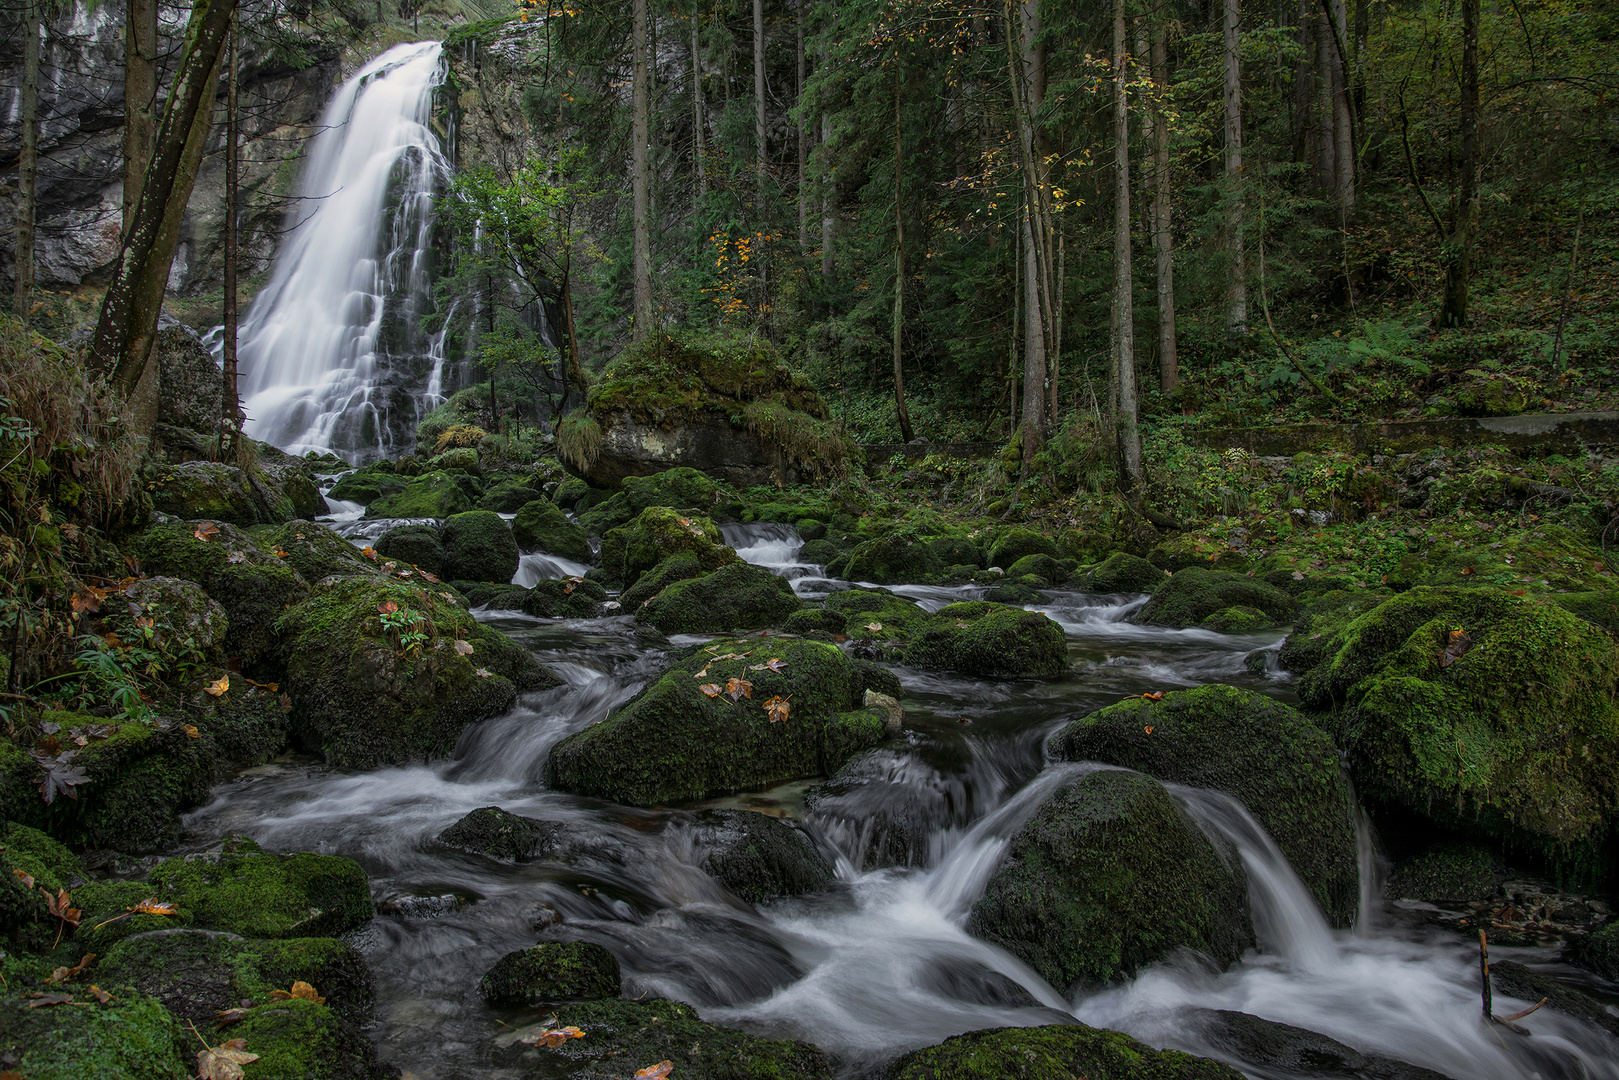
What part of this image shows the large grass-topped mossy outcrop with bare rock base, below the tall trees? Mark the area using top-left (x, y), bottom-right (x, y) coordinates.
top-left (557, 332), bottom-right (853, 487)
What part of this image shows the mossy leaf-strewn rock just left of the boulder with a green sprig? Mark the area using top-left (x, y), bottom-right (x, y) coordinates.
top-left (125, 521), bottom-right (309, 665)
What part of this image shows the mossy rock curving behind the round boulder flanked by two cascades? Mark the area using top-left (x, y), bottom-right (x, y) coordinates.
top-left (1051, 687), bottom-right (1360, 926)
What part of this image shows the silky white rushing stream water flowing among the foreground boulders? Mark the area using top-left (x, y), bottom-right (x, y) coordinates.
top-left (174, 526), bottom-right (1619, 1080)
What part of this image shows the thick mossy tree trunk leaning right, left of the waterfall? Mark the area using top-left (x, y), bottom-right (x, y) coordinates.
top-left (91, 0), bottom-right (233, 398)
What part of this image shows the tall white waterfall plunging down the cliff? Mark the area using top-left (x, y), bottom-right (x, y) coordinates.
top-left (240, 42), bottom-right (448, 463)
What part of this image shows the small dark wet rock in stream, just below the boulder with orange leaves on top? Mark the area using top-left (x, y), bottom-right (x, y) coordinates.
top-left (693, 810), bottom-right (832, 904)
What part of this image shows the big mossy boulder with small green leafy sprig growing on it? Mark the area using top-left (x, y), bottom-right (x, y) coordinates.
top-left (280, 573), bottom-right (516, 769)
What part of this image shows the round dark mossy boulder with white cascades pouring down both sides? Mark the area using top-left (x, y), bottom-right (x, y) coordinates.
top-left (967, 769), bottom-right (1253, 996)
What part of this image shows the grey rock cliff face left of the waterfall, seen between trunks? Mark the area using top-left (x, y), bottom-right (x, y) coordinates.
top-left (0, 0), bottom-right (340, 304)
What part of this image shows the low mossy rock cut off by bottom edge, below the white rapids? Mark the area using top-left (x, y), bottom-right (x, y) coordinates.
top-left (882, 1023), bottom-right (1242, 1080)
